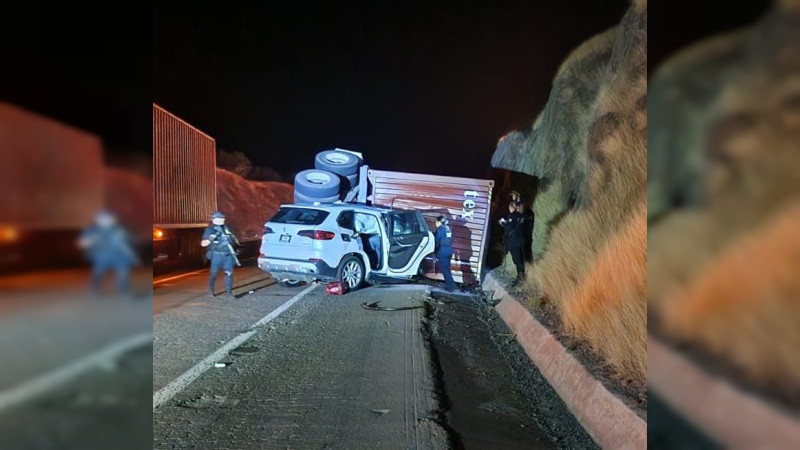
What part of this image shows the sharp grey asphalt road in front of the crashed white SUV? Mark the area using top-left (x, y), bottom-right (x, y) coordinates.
top-left (153, 268), bottom-right (591, 449)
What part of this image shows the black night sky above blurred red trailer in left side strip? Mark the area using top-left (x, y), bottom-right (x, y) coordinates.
top-left (0, 0), bottom-right (153, 155)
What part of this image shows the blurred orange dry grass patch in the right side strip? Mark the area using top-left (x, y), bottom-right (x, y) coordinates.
top-left (660, 201), bottom-right (800, 395)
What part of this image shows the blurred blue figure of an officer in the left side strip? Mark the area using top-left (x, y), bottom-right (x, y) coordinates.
top-left (78, 211), bottom-right (139, 294)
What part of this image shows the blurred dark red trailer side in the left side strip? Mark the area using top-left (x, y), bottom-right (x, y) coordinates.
top-left (0, 102), bottom-right (103, 230)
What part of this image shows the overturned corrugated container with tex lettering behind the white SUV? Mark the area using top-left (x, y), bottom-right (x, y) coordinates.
top-left (368, 170), bottom-right (494, 285)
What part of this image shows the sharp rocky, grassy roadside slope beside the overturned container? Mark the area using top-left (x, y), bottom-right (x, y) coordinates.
top-left (492, 0), bottom-right (647, 392)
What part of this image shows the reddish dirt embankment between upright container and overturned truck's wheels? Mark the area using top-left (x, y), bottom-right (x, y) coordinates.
top-left (217, 168), bottom-right (294, 241)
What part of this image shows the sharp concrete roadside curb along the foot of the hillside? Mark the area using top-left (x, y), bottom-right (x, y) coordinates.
top-left (483, 274), bottom-right (647, 449)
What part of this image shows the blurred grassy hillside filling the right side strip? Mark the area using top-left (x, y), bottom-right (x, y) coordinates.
top-left (647, 0), bottom-right (800, 405)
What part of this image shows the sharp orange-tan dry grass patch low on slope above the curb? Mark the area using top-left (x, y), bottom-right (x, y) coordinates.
top-left (561, 204), bottom-right (647, 382)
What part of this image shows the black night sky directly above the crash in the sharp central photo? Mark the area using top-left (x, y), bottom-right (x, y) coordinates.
top-left (154, 0), bottom-right (627, 177)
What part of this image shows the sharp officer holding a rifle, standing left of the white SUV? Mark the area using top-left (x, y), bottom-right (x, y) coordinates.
top-left (200, 211), bottom-right (239, 297)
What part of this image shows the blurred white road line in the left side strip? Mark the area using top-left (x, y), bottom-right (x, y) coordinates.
top-left (0, 331), bottom-right (153, 413)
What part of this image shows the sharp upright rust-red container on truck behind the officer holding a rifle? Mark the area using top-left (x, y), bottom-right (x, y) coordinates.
top-left (153, 104), bottom-right (217, 264)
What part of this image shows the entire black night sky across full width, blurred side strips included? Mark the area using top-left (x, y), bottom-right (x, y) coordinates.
top-left (0, 0), bottom-right (776, 171)
